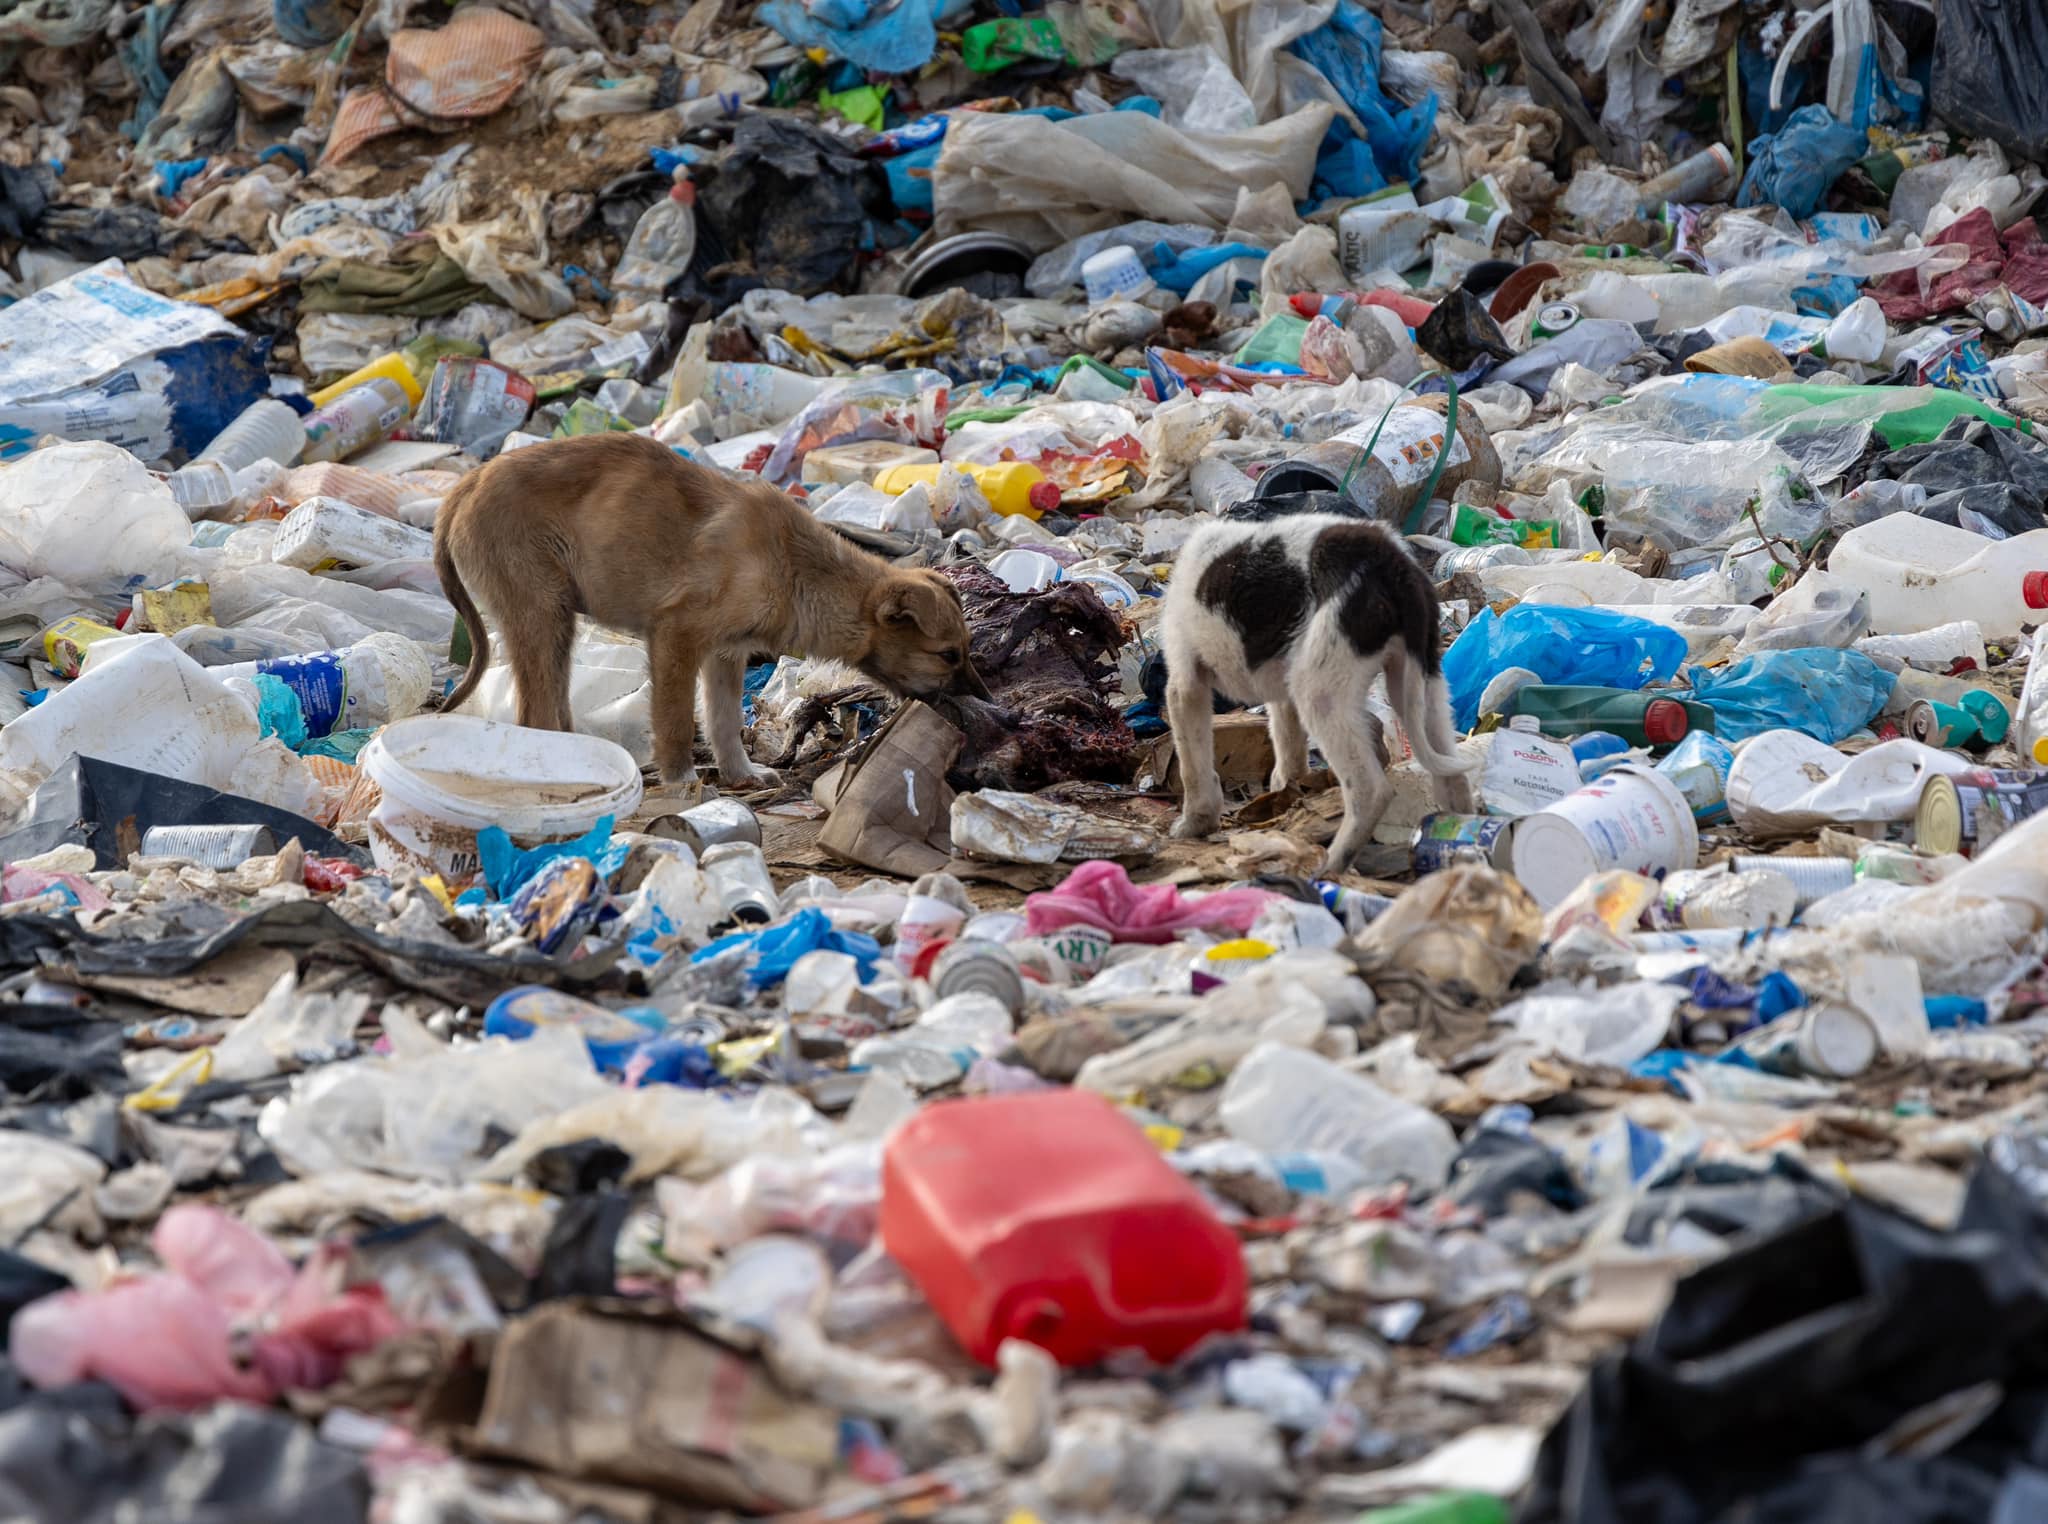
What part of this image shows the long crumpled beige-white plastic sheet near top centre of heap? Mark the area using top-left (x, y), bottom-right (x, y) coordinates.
top-left (932, 102), bottom-right (1333, 250)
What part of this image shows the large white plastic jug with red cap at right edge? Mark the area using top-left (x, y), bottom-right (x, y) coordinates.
top-left (1827, 514), bottom-right (2048, 637)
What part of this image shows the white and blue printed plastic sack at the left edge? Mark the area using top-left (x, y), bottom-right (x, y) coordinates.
top-left (0, 260), bottom-right (270, 461)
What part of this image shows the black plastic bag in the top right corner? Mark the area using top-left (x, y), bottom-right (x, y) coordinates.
top-left (1933, 0), bottom-right (2048, 160)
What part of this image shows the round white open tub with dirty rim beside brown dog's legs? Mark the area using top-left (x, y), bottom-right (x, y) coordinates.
top-left (360, 715), bottom-right (641, 883)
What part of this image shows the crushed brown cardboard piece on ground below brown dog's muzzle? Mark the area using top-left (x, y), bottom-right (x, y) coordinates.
top-left (817, 703), bottom-right (967, 879)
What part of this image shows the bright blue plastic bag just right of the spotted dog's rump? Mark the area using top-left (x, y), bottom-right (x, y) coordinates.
top-left (1444, 604), bottom-right (1686, 729)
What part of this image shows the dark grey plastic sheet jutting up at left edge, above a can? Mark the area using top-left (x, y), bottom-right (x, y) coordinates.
top-left (0, 756), bottom-right (371, 871)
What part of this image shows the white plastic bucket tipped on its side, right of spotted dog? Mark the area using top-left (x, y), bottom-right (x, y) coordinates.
top-left (1509, 762), bottom-right (1700, 909)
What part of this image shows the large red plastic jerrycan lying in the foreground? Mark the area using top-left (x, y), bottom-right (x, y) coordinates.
top-left (881, 1090), bottom-right (1245, 1366)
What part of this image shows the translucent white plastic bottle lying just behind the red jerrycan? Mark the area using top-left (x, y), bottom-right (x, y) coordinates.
top-left (1221, 1043), bottom-right (1458, 1190)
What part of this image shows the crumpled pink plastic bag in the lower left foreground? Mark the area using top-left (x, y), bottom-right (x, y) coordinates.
top-left (8, 1204), bottom-right (403, 1409)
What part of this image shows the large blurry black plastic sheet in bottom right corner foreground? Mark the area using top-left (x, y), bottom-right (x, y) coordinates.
top-left (1516, 1163), bottom-right (2048, 1524)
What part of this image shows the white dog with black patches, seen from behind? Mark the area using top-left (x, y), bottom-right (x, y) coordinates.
top-left (1161, 514), bottom-right (1475, 873)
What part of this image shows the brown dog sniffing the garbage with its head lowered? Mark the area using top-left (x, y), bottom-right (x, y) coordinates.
top-left (434, 434), bottom-right (987, 787)
